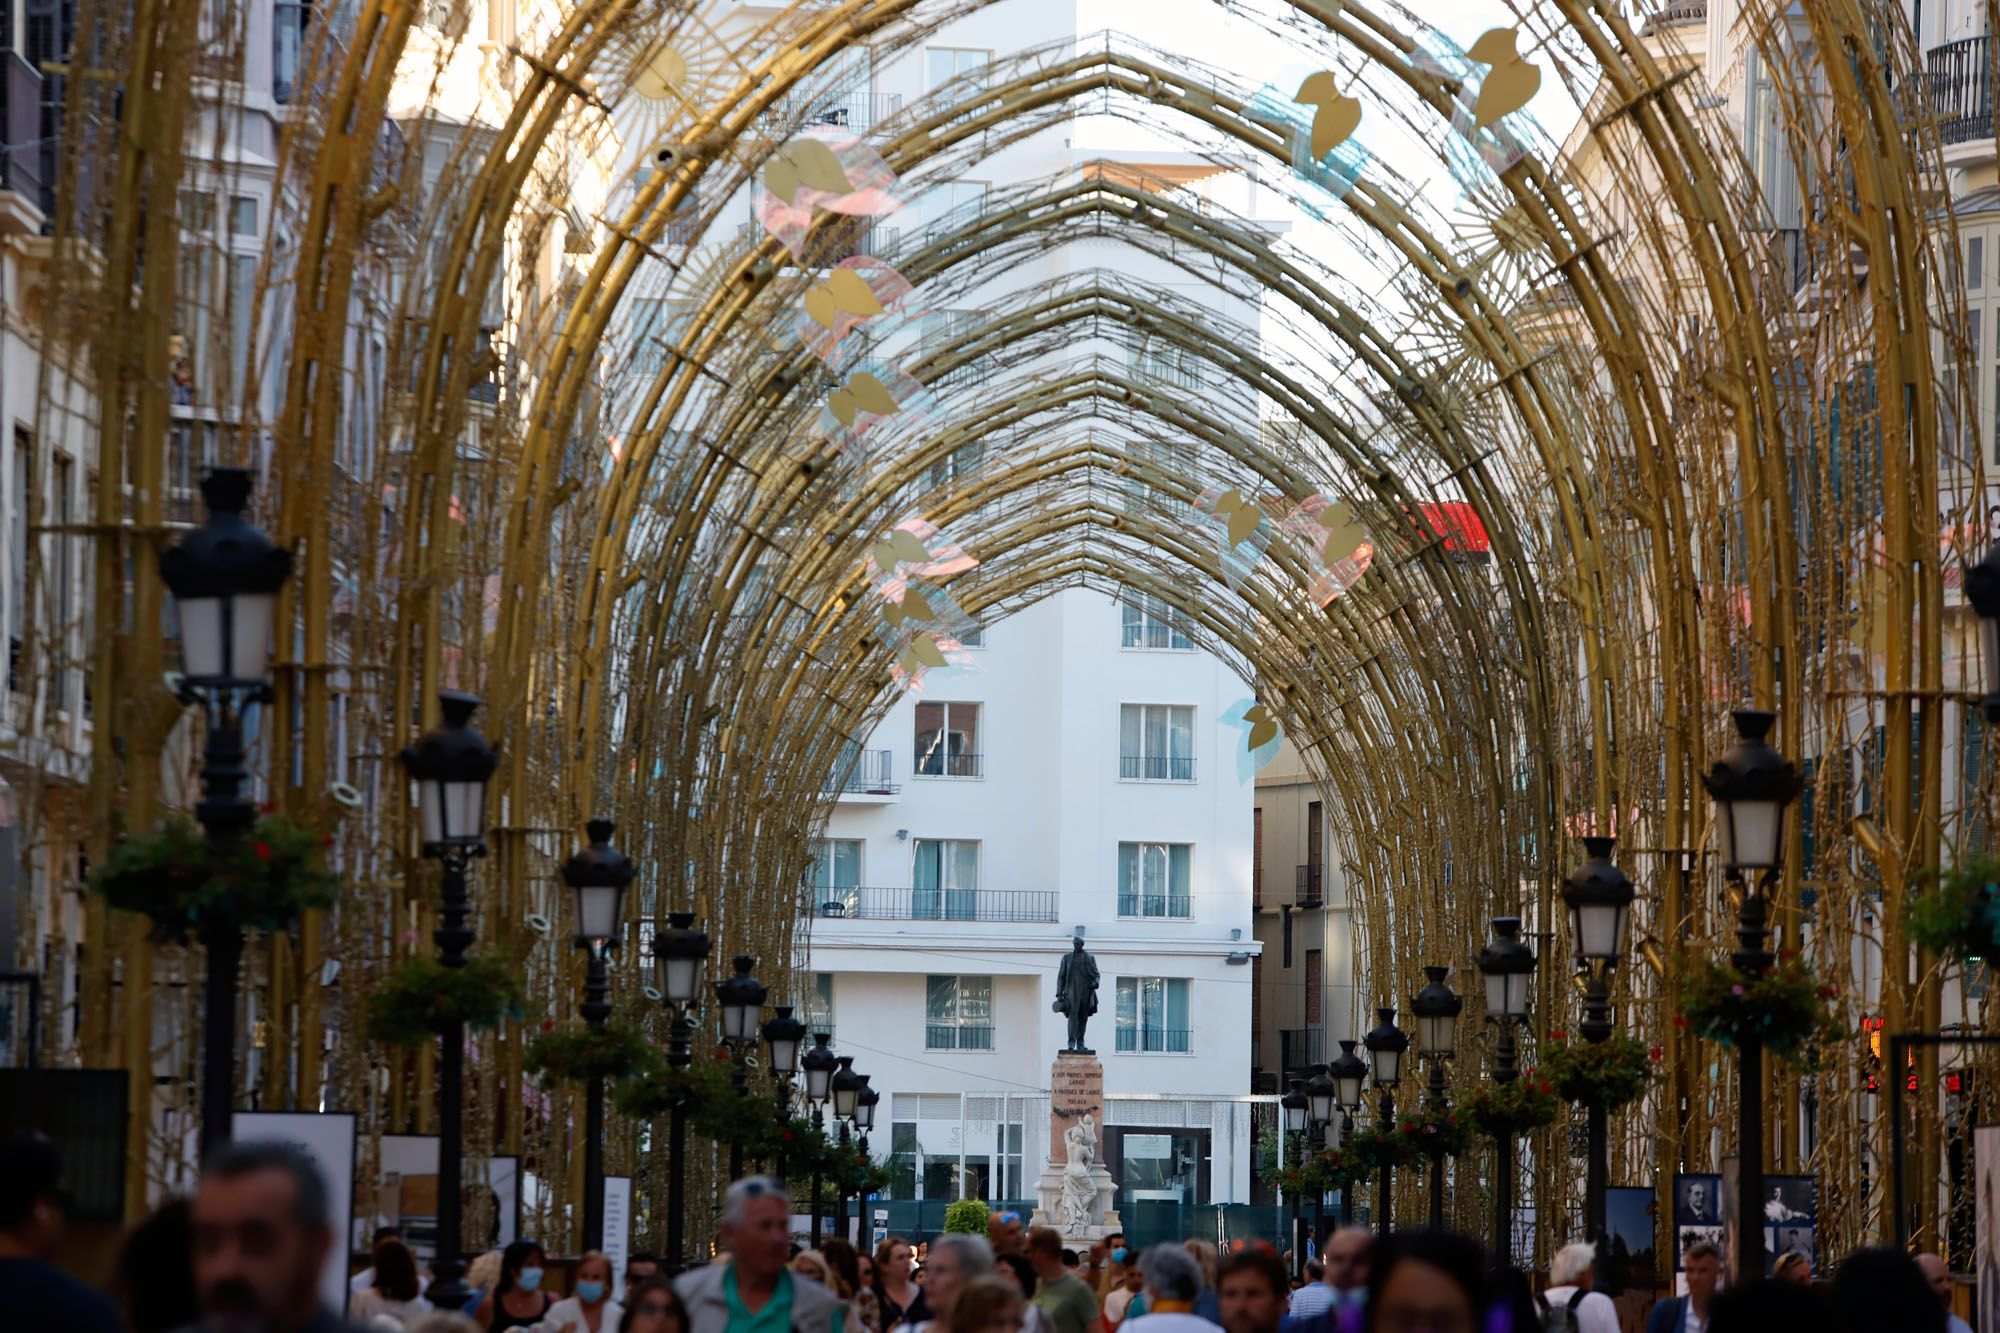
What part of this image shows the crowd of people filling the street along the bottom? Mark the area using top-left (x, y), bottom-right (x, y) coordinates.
top-left (0, 1133), bottom-right (1968, 1333)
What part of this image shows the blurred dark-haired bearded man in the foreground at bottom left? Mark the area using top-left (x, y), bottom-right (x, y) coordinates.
top-left (194, 1143), bottom-right (352, 1333)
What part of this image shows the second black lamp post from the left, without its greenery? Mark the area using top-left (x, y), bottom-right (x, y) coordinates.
top-left (402, 691), bottom-right (500, 1309)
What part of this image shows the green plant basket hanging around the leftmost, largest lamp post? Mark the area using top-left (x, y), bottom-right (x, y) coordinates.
top-left (90, 815), bottom-right (340, 945)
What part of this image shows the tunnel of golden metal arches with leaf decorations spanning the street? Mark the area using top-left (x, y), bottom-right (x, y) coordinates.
top-left (16, 0), bottom-right (1994, 1253)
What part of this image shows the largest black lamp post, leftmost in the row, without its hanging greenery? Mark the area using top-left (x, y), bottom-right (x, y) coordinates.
top-left (160, 468), bottom-right (292, 1153)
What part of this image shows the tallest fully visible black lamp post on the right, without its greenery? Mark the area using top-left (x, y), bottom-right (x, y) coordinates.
top-left (1702, 704), bottom-right (1800, 1283)
